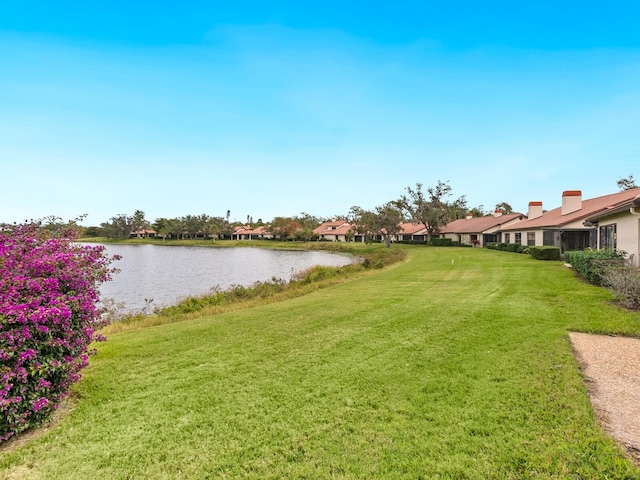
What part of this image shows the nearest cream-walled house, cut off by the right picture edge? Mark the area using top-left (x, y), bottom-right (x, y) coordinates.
top-left (584, 194), bottom-right (640, 267)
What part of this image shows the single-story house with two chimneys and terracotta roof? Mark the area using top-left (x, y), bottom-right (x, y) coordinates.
top-left (500, 188), bottom-right (640, 253)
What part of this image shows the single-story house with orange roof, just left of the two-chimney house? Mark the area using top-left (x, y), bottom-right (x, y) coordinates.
top-left (439, 210), bottom-right (526, 247)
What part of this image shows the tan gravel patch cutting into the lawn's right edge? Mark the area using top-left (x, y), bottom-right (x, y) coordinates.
top-left (569, 332), bottom-right (640, 462)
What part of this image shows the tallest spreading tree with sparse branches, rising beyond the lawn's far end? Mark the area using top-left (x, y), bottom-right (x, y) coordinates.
top-left (395, 180), bottom-right (467, 241)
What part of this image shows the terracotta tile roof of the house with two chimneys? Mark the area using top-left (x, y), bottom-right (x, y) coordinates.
top-left (501, 188), bottom-right (640, 231)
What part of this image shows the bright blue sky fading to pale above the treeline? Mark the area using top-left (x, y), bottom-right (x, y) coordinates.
top-left (0, 0), bottom-right (640, 225)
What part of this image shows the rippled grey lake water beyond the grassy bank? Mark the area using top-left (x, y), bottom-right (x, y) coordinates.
top-left (100, 245), bottom-right (353, 311)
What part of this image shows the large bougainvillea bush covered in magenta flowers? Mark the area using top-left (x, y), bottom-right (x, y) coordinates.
top-left (0, 222), bottom-right (113, 443)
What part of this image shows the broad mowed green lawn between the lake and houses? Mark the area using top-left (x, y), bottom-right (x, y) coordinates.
top-left (0, 247), bottom-right (640, 479)
